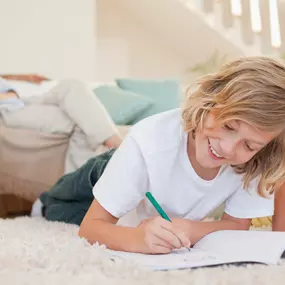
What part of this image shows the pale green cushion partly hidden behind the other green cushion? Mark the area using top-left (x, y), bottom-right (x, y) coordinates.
top-left (116, 79), bottom-right (181, 123)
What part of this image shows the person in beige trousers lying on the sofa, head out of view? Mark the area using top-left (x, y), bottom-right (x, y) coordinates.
top-left (0, 75), bottom-right (121, 173)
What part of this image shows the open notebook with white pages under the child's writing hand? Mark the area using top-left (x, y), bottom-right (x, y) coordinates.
top-left (103, 231), bottom-right (285, 270)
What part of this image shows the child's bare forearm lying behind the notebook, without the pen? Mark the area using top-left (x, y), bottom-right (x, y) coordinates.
top-left (172, 213), bottom-right (248, 244)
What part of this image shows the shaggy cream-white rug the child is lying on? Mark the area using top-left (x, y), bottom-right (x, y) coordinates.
top-left (0, 217), bottom-right (285, 285)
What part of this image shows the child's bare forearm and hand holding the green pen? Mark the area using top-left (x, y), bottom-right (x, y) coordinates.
top-left (78, 199), bottom-right (191, 254)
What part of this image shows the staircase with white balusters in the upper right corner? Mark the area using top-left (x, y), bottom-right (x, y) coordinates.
top-left (178, 0), bottom-right (285, 58)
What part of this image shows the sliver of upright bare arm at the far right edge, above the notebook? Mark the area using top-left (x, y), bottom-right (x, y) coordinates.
top-left (272, 183), bottom-right (285, 232)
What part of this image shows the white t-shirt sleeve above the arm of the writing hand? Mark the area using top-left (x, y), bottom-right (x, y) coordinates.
top-left (93, 135), bottom-right (148, 218)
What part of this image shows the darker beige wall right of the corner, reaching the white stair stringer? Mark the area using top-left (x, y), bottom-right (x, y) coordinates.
top-left (97, 0), bottom-right (242, 82)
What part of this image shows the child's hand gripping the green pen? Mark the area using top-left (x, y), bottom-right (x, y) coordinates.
top-left (135, 217), bottom-right (191, 254)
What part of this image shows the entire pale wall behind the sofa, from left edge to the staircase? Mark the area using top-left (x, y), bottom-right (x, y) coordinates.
top-left (0, 0), bottom-right (245, 81)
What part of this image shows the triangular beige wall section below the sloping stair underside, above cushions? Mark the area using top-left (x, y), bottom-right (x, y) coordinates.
top-left (97, 0), bottom-right (183, 81)
